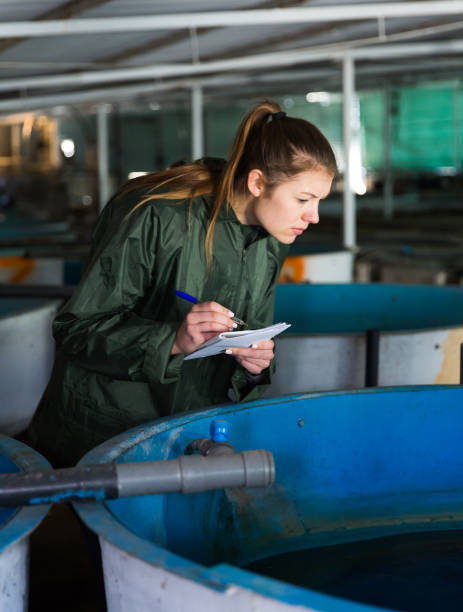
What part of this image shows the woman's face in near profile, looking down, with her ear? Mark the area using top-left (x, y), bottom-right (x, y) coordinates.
top-left (248, 168), bottom-right (333, 244)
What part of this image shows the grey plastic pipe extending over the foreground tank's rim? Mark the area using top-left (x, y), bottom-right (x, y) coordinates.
top-left (0, 450), bottom-right (275, 506)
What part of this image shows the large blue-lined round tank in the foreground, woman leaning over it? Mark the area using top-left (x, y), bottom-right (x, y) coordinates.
top-left (76, 386), bottom-right (463, 612)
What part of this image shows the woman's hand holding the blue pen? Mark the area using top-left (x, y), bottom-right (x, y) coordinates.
top-left (171, 302), bottom-right (237, 355)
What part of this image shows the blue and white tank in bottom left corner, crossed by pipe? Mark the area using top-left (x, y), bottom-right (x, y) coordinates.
top-left (0, 435), bottom-right (51, 612)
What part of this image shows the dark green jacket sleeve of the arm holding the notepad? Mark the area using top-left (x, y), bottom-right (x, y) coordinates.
top-left (231, 241), bottom-right (288, 402)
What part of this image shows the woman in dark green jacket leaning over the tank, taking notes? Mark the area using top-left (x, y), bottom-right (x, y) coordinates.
top-left (29, 101), bottom-right (336, 466)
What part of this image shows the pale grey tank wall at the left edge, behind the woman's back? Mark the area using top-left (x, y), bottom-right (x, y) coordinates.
top-left (0, 298), bottom-right (60, 435)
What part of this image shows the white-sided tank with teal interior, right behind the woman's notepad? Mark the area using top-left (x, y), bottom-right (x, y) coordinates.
top-left (266, 284), bottom-right (463, 397)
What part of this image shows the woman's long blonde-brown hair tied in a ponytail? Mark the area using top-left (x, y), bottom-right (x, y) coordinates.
top-left (120, 100), bottom-right (337, 265)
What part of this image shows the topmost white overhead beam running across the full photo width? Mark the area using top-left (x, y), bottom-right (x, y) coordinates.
top-left (0, 0), bottom-right (463, 38)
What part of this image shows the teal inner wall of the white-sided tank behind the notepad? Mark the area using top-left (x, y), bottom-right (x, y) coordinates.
top-left (275, 283), bottom-right (463, 334)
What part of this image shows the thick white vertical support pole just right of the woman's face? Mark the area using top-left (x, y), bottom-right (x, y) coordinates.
top-left (342, 55), bottom-right (356, 249)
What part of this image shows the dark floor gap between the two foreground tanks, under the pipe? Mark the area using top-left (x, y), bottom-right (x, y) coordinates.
top-left (29, 504), bottom-right (106, 612)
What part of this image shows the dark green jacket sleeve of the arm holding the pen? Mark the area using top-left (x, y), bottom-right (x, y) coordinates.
top-left (53, 206), bottom-right (183, 383)
